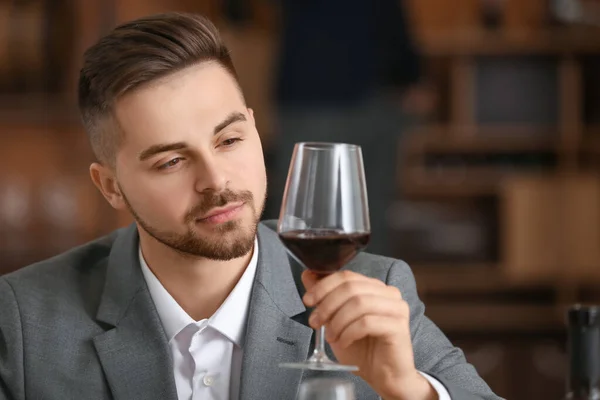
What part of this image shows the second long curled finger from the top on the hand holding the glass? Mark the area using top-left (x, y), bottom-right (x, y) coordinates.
top-left (325, 295), bottom-right (410, 343)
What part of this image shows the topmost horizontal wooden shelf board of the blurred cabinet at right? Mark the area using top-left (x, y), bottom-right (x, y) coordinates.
top-left (420, 27), bottom-right (600, 56)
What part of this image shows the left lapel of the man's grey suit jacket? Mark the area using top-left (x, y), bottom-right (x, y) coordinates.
top-left (94, 225), bottom-right (177, 400)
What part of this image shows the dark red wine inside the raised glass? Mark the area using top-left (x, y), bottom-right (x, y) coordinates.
top-left (279, 229), bottom-right (371, 275)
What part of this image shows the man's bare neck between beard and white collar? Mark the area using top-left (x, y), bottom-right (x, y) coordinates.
top-left (138, 229), bottom-right (254, 321)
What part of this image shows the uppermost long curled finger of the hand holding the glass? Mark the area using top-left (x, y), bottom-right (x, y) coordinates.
top-left (309, 280), bottom-right (402, 327)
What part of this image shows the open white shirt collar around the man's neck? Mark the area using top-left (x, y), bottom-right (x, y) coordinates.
top-left (138, 239), bottom-right (259, 347)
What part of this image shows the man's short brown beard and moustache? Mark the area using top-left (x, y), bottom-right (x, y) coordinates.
top-left (121, 189), bottom-right (265, 261)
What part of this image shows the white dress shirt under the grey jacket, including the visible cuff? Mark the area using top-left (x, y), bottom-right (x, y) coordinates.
top-left (139, 241), bottom-right (451, 400)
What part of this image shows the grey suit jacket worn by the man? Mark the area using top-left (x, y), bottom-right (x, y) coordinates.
top-left (0, 224), bottom-right (497, 400)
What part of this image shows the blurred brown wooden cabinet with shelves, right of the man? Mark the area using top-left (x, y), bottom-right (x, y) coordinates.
top-left (398, 0), bottom-right (600, 400)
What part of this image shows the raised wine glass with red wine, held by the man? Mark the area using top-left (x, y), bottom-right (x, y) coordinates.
top-left (277, 142), bottom-right (371, 371)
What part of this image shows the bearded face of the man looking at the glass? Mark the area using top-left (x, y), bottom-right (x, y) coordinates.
top-left (115, 62), bottom-right (266, 260)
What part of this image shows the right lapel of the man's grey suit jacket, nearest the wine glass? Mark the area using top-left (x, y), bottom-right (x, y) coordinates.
top-left (240, 224), bottom-right (313, 400)
